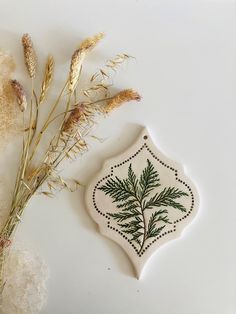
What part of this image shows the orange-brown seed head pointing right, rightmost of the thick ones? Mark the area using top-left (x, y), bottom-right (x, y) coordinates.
top-left (104, 89), bottom-right (141, 113)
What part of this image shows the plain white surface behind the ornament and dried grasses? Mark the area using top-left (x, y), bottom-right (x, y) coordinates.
top-left (0, 0), bottom-right (236, 314)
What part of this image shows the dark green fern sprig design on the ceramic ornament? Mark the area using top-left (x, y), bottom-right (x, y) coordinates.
top-left (98, 159), bottom-right (188, 253)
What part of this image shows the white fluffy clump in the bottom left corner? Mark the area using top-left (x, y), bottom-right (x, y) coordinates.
top-left (1, 249), bottom-right (48, 314)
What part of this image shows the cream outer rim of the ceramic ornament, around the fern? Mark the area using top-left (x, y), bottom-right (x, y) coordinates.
top-left (85, 128), bottom-right (199, 279)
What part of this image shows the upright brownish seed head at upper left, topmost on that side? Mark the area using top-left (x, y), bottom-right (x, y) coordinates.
top-left (22, 34), bottom-right (37, 78)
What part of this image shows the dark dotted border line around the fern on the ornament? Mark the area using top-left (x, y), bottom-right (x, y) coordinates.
top-left (93, 135), bottom-right (195, 257)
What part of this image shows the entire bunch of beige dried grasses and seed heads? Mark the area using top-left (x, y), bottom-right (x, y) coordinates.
top-left (0, 33), bottom-right (140, 304)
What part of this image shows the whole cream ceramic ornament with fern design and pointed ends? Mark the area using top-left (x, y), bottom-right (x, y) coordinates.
top-left (86, 129), bottom-right (198, 278)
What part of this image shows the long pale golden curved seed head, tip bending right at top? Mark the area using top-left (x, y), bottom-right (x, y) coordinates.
top-left (69, 33), bottom-right (103, 93)
